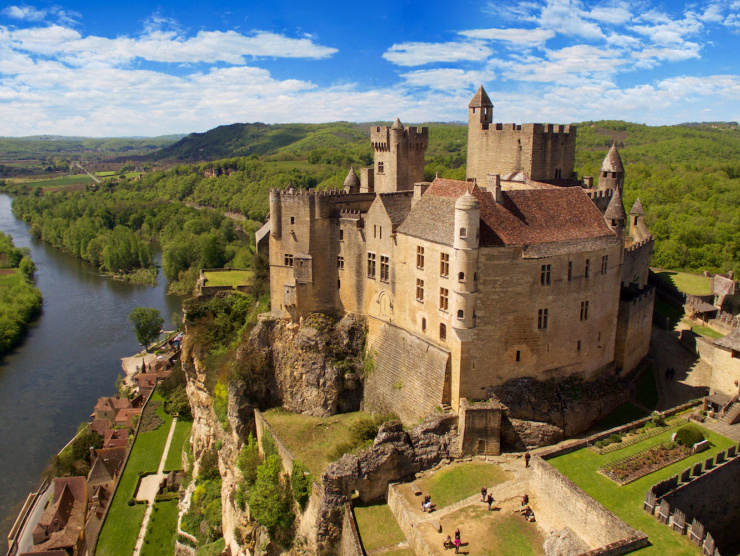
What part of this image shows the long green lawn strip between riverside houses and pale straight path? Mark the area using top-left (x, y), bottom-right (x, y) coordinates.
top-left (96, 392), bottom-right (172, 556)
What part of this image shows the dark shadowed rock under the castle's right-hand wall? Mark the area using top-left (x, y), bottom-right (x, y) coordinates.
top-left (489, 370), bottom-right (630, 451)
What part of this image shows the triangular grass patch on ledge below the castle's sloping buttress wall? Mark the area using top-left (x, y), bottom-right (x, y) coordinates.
top-left (264, 408), bottom-right (369, 480)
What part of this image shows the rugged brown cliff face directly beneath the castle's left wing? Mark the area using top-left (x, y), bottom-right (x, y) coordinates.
top-left (248, 314), bottom-right (365, 417)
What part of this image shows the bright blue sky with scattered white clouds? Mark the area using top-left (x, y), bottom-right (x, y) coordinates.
top-left (0, 0), bottom-right (740, 137)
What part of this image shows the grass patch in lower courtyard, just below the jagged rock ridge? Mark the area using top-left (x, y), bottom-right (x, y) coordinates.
top-left (414, 463), bottom-right (511, 509)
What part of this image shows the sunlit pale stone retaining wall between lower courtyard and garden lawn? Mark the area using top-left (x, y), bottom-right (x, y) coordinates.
top-left (530, 456), bottom-right (648, 556)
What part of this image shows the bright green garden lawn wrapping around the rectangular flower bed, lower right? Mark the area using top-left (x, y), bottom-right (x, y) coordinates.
top-left (549, 428), bottom-right (733, 556)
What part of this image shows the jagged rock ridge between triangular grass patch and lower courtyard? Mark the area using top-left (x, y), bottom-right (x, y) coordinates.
top-left (317, 413), bottom-right (458, 554)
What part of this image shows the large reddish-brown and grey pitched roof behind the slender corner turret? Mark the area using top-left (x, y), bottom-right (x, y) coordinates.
top-left (399, 178), bottom-right (619, 250)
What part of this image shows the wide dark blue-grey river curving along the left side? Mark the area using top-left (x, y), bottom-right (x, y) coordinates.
top-left (0, 194), bottom-right (181, 542)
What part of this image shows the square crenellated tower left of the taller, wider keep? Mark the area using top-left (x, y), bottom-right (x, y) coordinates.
top-left (368, 118), bottom-right (429, 193)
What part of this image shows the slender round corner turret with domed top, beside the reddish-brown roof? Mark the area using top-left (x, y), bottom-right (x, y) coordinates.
top-left (452, 193), bottom-right (480, 329)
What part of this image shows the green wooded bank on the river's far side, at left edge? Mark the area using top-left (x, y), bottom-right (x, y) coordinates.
top-left (0, 232), bottom-right (41, 356)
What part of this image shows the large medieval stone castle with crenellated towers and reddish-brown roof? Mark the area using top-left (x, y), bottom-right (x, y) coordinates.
top-left (265, 87), bottom-right (654, 444)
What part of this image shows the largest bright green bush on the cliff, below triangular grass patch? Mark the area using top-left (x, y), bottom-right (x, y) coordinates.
top-left (249, 454), bottom-right (295, 540)
